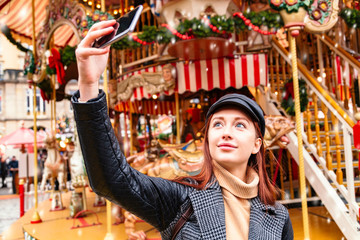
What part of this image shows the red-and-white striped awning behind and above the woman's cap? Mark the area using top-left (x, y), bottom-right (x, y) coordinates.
top-left (118, 53), bottom-right (268, 101)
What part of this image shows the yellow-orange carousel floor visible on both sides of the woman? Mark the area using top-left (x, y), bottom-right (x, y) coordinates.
top-left (0, 190), bottom-right (345, 240)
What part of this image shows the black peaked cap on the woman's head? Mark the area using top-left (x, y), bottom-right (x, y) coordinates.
top-left (205, 93), bottom-right (265, 136)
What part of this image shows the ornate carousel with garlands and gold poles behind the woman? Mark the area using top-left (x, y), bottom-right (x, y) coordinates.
top-left (0, 0), bottom-right (360, 239)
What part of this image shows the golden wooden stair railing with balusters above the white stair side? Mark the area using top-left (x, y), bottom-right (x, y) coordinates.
top-left (269, 37), bottom-right (359, 227)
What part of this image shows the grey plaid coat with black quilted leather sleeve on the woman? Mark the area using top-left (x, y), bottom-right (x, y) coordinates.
top-left (72, 91), bottom-right (293, 240)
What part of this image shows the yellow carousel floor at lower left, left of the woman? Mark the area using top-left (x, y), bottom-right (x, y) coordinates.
top-left (0, 190), bottom-right (161, 240)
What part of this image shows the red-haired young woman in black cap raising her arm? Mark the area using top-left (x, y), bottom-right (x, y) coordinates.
top-left (72, 20), bottom-right (293, 240)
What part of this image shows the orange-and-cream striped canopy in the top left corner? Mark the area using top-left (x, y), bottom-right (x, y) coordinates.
top-left (0, 0), bottom-right (77, 47)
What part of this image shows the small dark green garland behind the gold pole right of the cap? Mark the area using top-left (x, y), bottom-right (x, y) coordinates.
top-left (281, 78), bottom-right (309, 116)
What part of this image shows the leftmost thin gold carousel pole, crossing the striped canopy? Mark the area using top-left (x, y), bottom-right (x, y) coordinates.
top-left (31, 0), bottom-right (42, 223)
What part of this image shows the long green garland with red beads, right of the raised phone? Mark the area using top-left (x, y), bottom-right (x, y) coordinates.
top-left (112, 11), bottom-right (284, 50)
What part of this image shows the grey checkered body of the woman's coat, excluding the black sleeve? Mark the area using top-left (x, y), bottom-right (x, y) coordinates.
top-left (161, 181), bottom-right (293, 240)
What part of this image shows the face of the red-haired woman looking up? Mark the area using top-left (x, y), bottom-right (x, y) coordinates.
top-left (208, 108), bottom-right (261, 179)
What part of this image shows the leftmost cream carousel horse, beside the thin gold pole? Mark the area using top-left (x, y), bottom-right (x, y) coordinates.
top-left (40, 136), bottom-right (65, 191)
